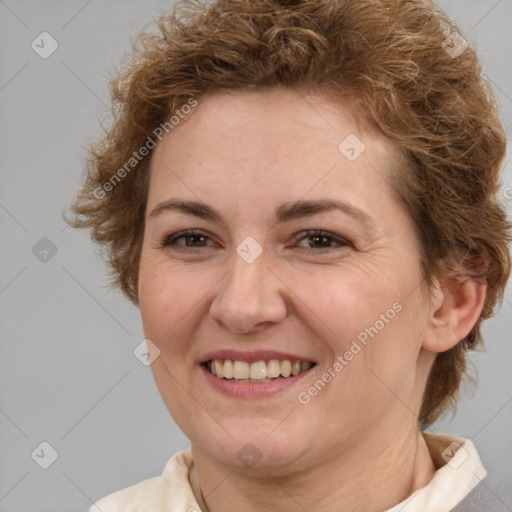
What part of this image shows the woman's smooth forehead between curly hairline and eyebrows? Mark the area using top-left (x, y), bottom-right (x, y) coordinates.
top-left (148, 88), bottom-right (394, 218)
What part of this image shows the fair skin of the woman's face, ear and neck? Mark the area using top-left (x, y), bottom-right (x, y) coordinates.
top-left (139, 88), bottom-right (485, 512)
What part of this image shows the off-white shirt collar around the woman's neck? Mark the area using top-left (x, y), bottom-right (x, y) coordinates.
top-left (89, 433), bottom-right (487, 512)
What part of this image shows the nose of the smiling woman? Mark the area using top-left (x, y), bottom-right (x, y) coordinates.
top-left (210, 249), bottom-right (288, 334)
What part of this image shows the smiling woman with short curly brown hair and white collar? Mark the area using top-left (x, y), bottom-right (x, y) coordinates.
top-left (69, 0), bottom-right (510, 512)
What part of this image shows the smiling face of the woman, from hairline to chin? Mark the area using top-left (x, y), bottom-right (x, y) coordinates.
top-left (139, 89), bottom-right (433, 470)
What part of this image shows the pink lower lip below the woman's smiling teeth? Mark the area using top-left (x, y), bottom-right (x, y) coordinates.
top-left (201, 366), bottom-right (314, 398)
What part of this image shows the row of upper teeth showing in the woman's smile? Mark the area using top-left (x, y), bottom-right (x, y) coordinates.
top-left (207, 359), bottom-right (313, 380)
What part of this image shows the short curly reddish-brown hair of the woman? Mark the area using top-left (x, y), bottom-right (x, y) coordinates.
top-left (68, 0), bottom-right (511, 428)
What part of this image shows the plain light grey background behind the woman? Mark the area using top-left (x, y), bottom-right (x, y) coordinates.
top-left (0, 0), bottom-right (512, 512)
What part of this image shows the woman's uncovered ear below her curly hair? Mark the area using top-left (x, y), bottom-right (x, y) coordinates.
top-left (422, 278), bottom-right (487, 353)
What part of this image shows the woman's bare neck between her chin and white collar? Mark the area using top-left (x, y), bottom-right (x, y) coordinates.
top-left (190, 428), bottom-right (435, 512)
